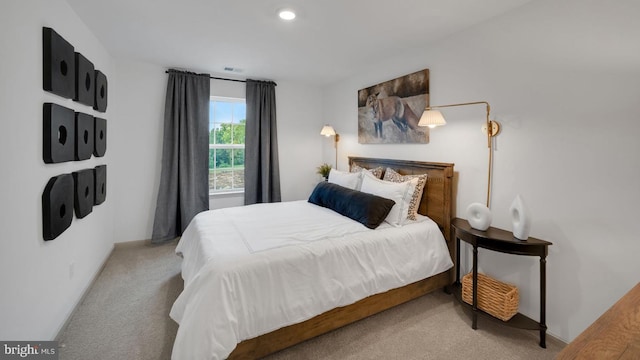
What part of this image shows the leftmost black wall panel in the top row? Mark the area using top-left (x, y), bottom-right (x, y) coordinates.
top-left (42, 27), bottom-right (76, 99)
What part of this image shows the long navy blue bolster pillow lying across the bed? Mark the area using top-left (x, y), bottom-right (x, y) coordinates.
top-left (309, 181), bottom-right (396, 229)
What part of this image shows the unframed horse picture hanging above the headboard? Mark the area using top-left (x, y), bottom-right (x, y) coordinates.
top-left (358, 69), bottom-right (429, 144)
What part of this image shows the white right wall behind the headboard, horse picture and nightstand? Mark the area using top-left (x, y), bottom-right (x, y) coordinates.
top-left (323, 0), bottom-right (640, 341)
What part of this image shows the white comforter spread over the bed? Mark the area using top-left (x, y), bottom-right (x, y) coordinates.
top-left (170, 201), bottom-right (453, 360)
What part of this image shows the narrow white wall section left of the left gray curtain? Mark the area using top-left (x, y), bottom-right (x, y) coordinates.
top-left (109, 59), bottom-right (167, 242)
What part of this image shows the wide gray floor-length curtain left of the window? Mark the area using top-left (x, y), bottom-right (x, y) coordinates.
top-left (151, 70), bottom-right (210, 243)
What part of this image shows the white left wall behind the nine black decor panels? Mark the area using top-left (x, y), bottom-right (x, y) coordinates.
top-left (0, 0), bottom-right (117, 340)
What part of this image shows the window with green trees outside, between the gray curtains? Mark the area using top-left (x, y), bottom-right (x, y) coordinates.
top-left (209, 96), bottom-right (247, 194)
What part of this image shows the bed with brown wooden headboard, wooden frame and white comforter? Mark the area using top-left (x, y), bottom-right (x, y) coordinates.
top-left (170, 157), bottom-right (453, 359)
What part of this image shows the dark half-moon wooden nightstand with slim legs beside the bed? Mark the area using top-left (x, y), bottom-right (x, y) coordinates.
top-left (451, 218), bottom-right (552, 348)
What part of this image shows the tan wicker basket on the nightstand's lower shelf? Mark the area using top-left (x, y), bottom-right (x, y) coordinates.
top-left (462, 273), bottom-right (520, 321)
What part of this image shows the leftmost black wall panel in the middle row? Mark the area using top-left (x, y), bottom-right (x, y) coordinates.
top-left (42, 103), bottom-right (76, 164)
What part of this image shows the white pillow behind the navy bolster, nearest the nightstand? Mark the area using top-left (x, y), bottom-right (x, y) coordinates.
top-left (360, 172), bottom-right (418, 226)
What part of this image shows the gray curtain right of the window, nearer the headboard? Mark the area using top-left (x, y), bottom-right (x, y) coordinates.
top-left (244, 80), bottom-right (280, 205)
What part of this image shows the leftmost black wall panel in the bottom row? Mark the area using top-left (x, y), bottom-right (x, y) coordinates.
top-left (42, 174), bottom-right (74, 240)
